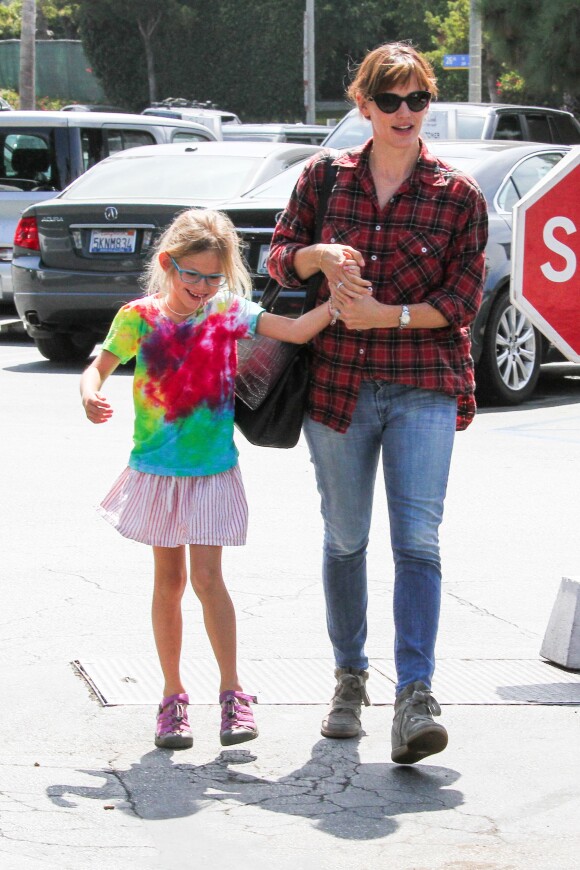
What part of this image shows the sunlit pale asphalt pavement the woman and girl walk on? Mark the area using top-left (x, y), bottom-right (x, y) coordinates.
top-left (0, 333), bottom-right (580, 870)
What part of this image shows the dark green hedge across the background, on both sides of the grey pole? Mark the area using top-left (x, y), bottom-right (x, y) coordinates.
top-left (78, 0), bottom-right (458, 120)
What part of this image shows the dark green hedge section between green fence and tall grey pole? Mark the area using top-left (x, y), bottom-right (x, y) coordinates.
top-left (80, 0), bottom-right (303, 119)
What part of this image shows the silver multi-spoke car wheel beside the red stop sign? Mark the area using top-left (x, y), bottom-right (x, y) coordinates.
top-left (476, 291), bottom-right (542, 405)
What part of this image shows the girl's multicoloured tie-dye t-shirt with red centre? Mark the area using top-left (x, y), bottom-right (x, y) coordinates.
top-left (103, 291), bottom-right (263, 477)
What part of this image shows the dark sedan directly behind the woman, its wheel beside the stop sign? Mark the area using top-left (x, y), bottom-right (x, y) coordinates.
top-left (224, 141), bottom-right (569, 405)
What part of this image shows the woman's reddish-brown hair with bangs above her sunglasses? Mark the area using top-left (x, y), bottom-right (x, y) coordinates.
top-left (346, 42), bottom-right (437, 103)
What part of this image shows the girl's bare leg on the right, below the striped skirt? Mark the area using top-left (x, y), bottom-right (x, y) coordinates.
top-left (189, 544), bottom-right (242, 692)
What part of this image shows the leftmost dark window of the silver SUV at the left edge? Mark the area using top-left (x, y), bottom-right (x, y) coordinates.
top-left (0, 128), bottom-right (57, 191)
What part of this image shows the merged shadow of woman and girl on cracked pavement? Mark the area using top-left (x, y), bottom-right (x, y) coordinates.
top-left (47, 740), bottom-right (463, 840)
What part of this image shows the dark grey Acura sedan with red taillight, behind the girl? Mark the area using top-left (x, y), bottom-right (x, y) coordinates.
top-left (12, 142), bottom-right (320, 362)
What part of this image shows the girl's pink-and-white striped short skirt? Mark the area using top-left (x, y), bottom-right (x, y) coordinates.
top-left (97, 465), bottom-right (248, 547)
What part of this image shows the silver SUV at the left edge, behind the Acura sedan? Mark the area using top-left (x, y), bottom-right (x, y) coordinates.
top-left (0, 111), bottom-right (217, 302)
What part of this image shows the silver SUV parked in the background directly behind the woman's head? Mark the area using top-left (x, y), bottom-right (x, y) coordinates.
top-left (323, 102), bottom-right (580, 148)
